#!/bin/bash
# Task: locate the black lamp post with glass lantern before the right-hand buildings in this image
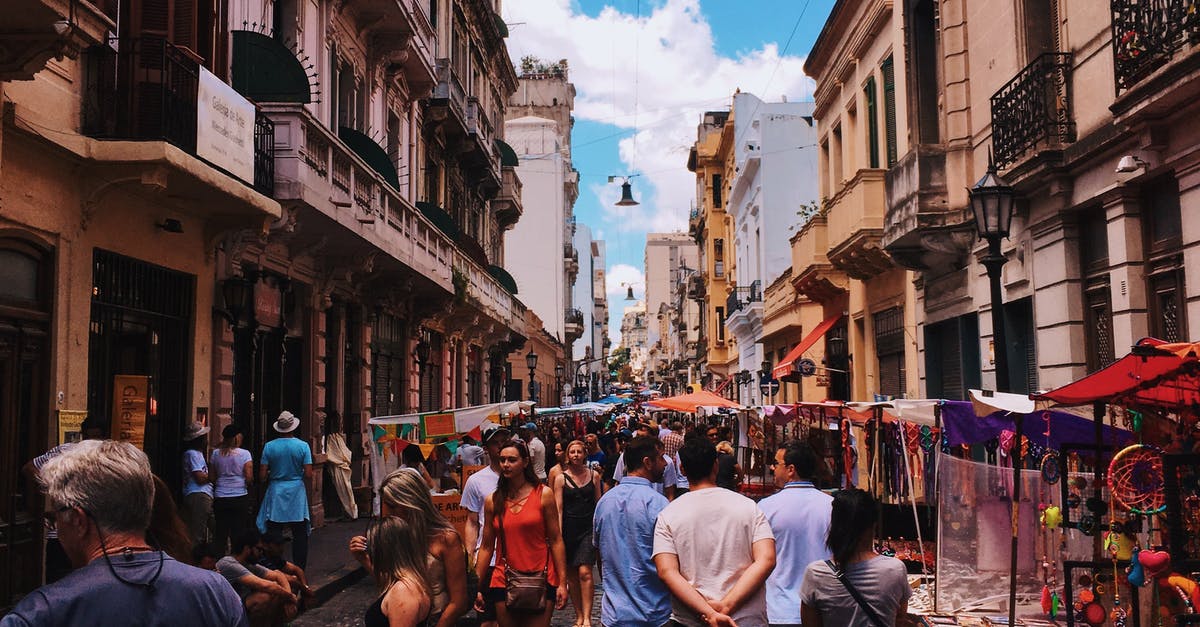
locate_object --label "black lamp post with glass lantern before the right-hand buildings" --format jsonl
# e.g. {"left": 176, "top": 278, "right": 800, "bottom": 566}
{"left": 968, "top": 155, "right": 1024, "bottom": 625}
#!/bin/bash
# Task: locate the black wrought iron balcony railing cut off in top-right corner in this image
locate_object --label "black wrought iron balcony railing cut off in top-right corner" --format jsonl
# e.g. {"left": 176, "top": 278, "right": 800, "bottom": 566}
{"left": 1110, "top": 0, "right": 1200, "bottom": 95}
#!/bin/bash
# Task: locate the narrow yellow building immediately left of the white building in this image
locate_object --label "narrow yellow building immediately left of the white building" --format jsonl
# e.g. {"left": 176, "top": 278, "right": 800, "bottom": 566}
{"left": 688, "top": 111, "right": 737, "bottom": 389}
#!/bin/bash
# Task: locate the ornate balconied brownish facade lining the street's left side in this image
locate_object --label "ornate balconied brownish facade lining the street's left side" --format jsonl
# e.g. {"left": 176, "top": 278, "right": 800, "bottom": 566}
{"left": 0, "top": 0, "right": 544, "bottom": 598}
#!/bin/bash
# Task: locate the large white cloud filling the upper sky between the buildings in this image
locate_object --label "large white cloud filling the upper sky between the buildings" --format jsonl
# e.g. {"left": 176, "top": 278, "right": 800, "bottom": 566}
{"left": 504, "top": 0, "right": 812, "bottom": 232}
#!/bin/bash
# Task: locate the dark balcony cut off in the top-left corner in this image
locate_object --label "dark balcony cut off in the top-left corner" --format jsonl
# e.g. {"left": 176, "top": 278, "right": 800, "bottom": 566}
{"left": 0, "top": 0, "right": 116, "bottom": 83}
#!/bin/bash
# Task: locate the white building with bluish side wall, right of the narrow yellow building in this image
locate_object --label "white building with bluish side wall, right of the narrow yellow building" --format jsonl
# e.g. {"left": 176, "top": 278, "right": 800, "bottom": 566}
{"left": 725, "top": 92, "right": 818, "bottom": 402}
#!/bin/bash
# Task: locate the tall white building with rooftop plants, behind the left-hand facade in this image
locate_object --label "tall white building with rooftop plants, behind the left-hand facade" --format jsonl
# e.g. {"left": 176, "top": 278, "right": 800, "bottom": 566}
{"left": 504, "top": 59, "right": 583, "bottom": 354}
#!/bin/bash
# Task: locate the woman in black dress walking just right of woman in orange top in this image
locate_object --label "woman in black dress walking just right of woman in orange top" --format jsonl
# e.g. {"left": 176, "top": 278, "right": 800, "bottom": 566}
{"left": 553, "top": 440, "right": 600, "bottom": 627}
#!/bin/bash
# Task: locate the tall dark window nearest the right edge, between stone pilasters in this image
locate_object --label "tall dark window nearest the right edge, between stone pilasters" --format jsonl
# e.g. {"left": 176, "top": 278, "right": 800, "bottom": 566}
{"left": 1142, "top": 175, "right": 1188, "bottom": 342}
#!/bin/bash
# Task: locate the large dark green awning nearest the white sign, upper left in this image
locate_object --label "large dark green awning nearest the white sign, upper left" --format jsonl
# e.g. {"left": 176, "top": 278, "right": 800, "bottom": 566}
{"left": 232, "top": 30, "right": 312, "bottom": 103}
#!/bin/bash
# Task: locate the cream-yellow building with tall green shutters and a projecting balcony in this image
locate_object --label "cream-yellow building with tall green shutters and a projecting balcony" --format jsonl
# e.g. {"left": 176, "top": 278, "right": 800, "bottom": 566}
{"left": 792, "top": 1, "right": 919, "bottom": 400}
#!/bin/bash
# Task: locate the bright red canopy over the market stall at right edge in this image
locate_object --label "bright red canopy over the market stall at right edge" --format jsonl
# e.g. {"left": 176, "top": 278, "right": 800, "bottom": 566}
{"left": 1031, "top": 338, "right": 1200, "bottom": 407}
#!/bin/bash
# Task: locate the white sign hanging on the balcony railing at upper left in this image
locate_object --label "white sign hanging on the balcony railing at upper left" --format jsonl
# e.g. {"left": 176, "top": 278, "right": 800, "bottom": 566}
{"left": 196, "top": 67, "right": 254, "bottom": 185}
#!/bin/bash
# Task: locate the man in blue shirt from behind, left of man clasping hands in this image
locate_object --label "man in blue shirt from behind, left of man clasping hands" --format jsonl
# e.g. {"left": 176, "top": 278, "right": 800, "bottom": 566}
{"left": 593, "top": 436, "right": 671, "bottom": 627}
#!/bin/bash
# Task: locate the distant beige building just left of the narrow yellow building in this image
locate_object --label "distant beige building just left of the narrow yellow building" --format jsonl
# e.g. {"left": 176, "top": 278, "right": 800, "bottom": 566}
{"left": 644, "top": 233, "right": 700, "bottom": 382}
